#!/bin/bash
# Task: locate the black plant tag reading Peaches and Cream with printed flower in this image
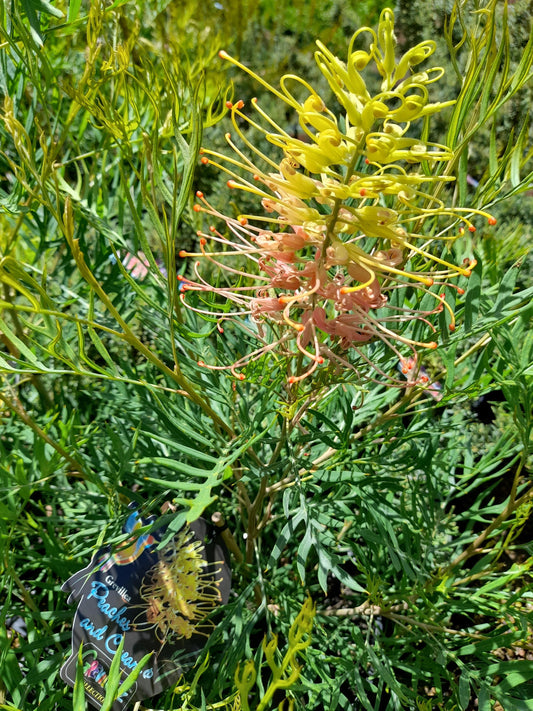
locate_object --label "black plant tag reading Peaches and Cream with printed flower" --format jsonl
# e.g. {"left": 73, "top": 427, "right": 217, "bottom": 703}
{"left": 61, "top": 512, "right": 231, "bottom": 711}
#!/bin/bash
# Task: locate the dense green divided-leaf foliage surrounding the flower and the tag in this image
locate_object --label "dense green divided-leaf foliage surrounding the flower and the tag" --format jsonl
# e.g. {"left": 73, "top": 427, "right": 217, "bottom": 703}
{"left": 0, "top": 0, "right": 533, "bottom": 711}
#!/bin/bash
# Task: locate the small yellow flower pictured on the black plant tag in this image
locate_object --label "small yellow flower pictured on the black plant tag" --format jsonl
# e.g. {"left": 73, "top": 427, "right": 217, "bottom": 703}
{"left": 135, "top": 529, "right": 221, "bottom": 644}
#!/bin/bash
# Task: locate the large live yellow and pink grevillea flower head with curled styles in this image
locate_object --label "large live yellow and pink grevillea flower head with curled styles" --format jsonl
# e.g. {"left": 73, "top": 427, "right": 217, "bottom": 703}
{"left": 180, "top": 9, "right": 495, "bottom": 386}
